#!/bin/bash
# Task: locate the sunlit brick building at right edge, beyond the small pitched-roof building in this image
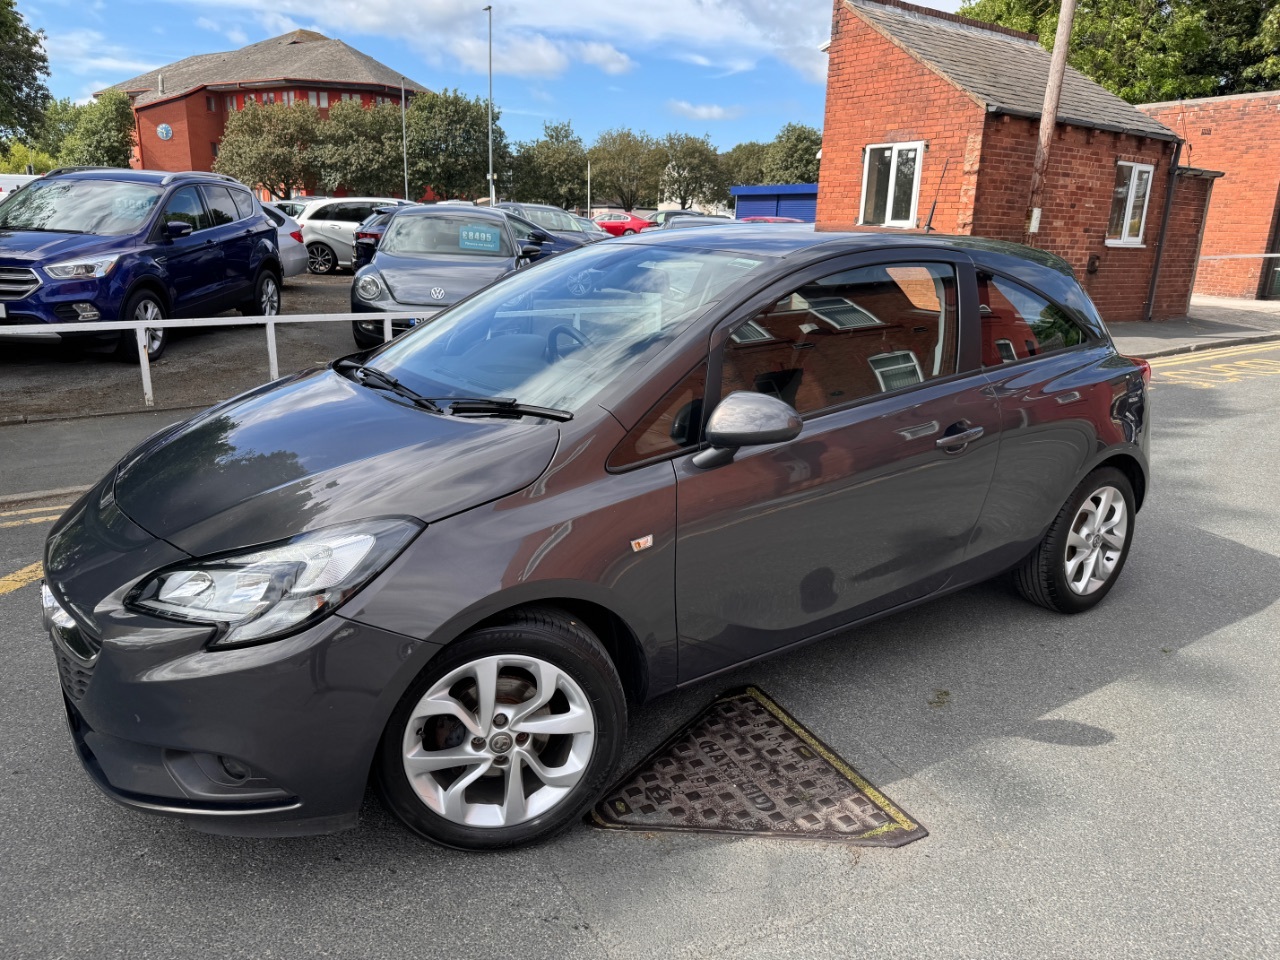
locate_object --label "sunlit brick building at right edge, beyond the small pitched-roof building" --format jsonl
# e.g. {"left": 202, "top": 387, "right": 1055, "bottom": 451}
{"left": 1138, "top": 91, "right": 1280, "bottom": 300}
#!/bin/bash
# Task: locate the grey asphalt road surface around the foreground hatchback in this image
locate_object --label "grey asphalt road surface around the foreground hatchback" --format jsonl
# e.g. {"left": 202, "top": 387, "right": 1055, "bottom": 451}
{"left": 0, "top": 344, "right": 1280, "bottom": 960}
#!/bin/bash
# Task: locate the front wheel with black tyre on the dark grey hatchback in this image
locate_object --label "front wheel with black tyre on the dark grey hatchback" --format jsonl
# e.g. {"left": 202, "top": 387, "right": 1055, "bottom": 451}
{"left": 376, "top": 608, "right": 626, "bottom": 850}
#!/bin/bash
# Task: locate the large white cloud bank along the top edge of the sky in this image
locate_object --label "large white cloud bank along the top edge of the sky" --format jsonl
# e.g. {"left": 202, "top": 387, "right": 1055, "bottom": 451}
{"left": 165, "top": 0, "right": 834, "bottom": 82}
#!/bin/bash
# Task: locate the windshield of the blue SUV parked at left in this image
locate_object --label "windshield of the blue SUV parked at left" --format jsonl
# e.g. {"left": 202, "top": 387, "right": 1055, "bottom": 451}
{"left": 0, "top": 179, "right": 164, "bottom": 237}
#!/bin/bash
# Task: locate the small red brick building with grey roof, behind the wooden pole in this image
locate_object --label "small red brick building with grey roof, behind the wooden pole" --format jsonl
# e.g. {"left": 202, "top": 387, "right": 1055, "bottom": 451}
{"left": 818, "top": 0, "right": 1220, "bottom": 320}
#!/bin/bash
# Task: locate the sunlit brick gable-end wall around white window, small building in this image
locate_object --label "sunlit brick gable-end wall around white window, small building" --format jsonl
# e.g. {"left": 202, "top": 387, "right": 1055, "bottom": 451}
{"left": 818, "top": 0, "right": 983, "bottom": 233}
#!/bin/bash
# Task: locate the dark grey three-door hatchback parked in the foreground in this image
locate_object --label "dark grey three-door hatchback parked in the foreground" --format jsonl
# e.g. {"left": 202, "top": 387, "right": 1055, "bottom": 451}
{"left": 44, "top": 224, "right": 1149, "bottom": 849}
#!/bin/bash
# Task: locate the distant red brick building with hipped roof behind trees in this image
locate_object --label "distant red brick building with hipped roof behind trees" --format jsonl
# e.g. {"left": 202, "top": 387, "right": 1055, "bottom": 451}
{"left": 106, "top": 29, "right": 426, "bottom": 185}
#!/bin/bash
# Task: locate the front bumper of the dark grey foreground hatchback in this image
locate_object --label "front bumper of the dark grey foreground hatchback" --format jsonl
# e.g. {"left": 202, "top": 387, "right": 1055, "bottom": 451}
{"left": 45, "top": 586, "right": 436, "bottom": 836}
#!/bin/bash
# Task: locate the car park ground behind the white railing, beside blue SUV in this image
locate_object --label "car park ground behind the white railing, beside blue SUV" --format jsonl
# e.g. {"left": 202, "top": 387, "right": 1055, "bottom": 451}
{"left": 0, "top": 271, "right": 356, "bottom": 422}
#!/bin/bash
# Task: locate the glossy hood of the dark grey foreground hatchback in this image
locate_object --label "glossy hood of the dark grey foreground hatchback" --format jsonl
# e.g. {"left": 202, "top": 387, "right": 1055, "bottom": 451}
{"left": 115, "top": 370, "right": 559, "bottom": 556}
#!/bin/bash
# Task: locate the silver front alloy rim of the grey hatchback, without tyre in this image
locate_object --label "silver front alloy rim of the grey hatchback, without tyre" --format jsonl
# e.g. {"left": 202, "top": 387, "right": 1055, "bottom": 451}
{"left": 402, "top": 654, "right": 595, "bottom": 827}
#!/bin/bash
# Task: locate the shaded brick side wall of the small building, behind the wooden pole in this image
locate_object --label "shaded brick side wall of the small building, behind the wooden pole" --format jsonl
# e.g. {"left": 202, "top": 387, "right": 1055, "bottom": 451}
{"left": 973, "top": 116, "right": 1172, "bottom": 321}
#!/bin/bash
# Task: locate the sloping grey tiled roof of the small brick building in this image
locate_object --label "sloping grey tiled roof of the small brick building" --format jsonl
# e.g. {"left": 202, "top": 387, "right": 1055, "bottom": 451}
{"left": 845, "top": 0, "right": 1178, "bottom": 140}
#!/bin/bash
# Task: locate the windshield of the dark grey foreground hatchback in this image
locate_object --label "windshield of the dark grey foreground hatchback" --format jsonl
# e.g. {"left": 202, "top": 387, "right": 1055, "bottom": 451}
{"left": 369, "top": 241, "right": 765, "bottom": 413}
